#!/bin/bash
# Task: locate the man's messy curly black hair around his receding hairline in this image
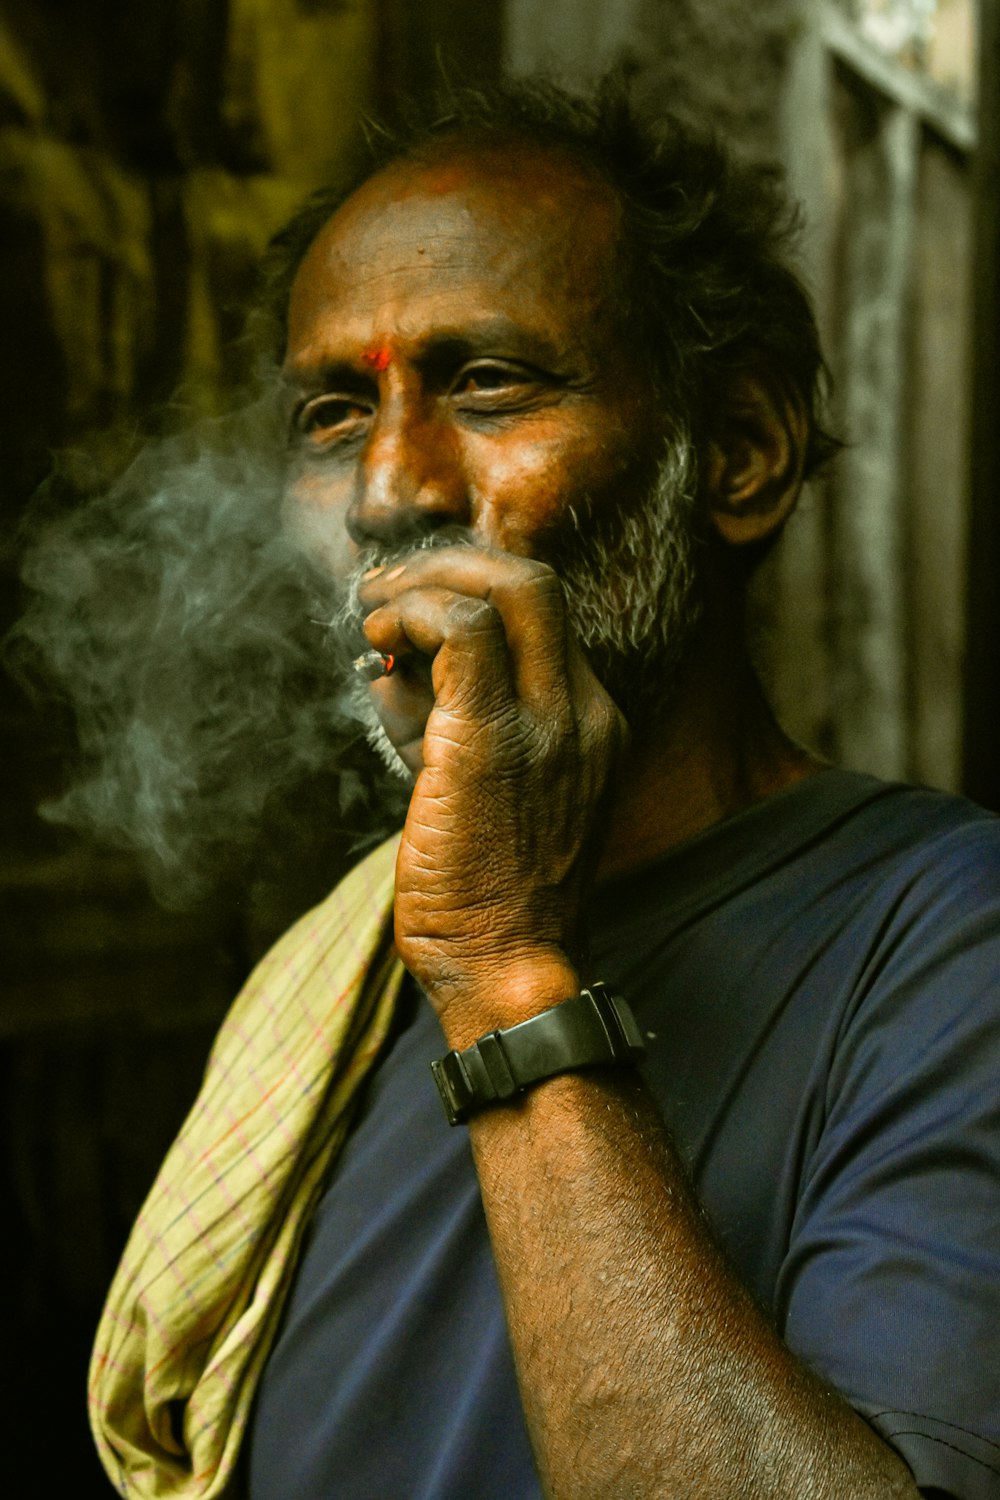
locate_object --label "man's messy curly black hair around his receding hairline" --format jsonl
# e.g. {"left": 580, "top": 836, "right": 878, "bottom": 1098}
{"left": 258, "top": 78, "right": 840, "bottom": 477}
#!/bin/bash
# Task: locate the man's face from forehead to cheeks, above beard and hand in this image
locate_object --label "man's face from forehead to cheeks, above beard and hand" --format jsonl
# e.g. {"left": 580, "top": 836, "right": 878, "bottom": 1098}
{"left": 285, "top": 149, "right": 660, "bottom": 573}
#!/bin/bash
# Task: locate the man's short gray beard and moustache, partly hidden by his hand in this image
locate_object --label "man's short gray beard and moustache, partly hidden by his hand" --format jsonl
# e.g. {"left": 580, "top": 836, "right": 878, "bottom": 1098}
{"left": 331, "top": 440, "right": 702, "bottom": 782}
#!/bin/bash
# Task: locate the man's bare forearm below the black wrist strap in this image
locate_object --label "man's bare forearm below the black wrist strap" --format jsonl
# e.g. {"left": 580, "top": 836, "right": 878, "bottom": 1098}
{"left": 471, "top": 1071, "right": 918, "bottom": 1500}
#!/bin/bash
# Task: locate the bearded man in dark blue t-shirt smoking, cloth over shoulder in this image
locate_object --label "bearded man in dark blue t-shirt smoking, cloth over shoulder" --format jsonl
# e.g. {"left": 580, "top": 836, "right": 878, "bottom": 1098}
{"left": 91, "top": 79, "right": 1000, "bottom": 1500}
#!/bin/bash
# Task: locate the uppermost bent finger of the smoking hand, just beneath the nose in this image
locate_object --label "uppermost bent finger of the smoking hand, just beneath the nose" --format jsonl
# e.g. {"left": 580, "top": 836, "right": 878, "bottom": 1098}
{"left": 358, "top": 546, "right": 570, "bottom": 710}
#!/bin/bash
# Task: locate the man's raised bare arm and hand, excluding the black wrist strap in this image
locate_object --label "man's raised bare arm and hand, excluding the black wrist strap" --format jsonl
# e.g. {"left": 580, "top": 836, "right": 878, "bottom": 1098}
{"left": 359, "top": 549, "right": 918, "bottom": 1500}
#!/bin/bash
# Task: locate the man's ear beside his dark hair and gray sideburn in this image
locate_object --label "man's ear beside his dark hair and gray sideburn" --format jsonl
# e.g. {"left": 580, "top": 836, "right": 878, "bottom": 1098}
{"left": 705, "top": 371, "right": 808, "bottom": 546}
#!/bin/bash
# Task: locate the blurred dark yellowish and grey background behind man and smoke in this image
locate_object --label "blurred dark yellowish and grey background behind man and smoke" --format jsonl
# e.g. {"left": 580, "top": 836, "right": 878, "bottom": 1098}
{"left": 0, "top": 0, "right": 997, "bottom": 1500}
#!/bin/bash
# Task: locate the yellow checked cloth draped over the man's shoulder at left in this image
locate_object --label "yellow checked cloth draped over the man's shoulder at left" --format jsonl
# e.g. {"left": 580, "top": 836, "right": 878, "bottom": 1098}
{"left": 90, "top": 839, "right": 403, "bottom": 1500}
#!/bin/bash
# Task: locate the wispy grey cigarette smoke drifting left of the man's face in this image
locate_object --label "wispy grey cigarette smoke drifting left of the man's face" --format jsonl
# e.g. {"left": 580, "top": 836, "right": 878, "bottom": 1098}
{"left": 10, "top": 395, "right": 406, "bottom": 905}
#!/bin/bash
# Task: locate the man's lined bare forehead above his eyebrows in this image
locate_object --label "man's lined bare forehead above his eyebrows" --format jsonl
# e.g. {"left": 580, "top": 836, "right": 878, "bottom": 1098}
{"left": 289, "top": 147, "right": 618, "bottom": 363}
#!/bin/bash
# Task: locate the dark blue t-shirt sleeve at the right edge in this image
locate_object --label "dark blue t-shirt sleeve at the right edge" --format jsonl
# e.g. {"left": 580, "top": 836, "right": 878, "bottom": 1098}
{"left": 777, "top": 822, "right": 1000, "bottom": 1500}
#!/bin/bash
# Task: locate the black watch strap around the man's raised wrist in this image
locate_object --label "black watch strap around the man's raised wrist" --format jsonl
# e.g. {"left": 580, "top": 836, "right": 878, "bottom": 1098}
{"left": 430, "top": 983, "right": 645, "bottom": 1125}
